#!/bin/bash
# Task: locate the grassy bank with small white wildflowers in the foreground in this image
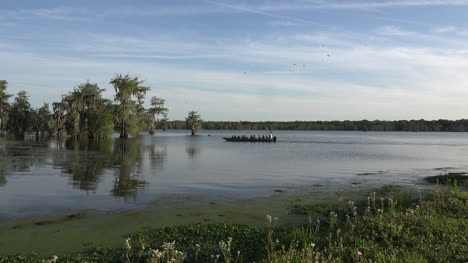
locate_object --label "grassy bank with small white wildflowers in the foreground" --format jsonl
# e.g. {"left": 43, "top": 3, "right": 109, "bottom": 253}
{"left": 0, "top": 179, "right": 468, "bottom": 263}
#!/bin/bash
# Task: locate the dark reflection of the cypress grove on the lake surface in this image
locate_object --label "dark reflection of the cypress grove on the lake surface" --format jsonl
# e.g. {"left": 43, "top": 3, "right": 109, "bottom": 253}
{"left": 0, "top": 138, "right": 167, "bottom": 197}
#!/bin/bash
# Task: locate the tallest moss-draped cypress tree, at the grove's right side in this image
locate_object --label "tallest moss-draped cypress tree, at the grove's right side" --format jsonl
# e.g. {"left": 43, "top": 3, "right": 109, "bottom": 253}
{"left": 110, "top": 75, "right": 149, "bottom": 138}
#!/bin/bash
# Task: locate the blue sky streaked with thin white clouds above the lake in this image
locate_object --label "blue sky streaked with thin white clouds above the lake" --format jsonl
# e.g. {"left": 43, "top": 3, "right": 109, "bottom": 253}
{"left": 0, "top": 0, "right": 468, "bottom": 121}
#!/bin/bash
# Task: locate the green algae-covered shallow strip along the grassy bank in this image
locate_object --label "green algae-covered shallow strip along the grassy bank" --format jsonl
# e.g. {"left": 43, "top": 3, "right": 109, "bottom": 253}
{"left": 0, "top": 185, "right": 434, "bottom": 256}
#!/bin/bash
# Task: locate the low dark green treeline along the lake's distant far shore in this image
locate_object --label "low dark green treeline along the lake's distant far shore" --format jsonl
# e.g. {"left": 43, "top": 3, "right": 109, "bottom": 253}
{"left": 166, "top": 119, "right": 468, "bottom": 132}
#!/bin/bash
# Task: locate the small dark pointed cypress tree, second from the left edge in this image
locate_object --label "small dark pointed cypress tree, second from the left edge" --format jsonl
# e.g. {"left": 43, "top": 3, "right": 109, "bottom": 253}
{"left": 7, "top": 90, "right": 32, "bottom": 138}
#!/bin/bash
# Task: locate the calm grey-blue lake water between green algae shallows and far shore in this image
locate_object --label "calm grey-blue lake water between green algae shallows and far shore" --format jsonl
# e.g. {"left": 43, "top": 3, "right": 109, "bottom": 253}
{"left": 0, "top": 131, "right": 468, "bottom": 218}
